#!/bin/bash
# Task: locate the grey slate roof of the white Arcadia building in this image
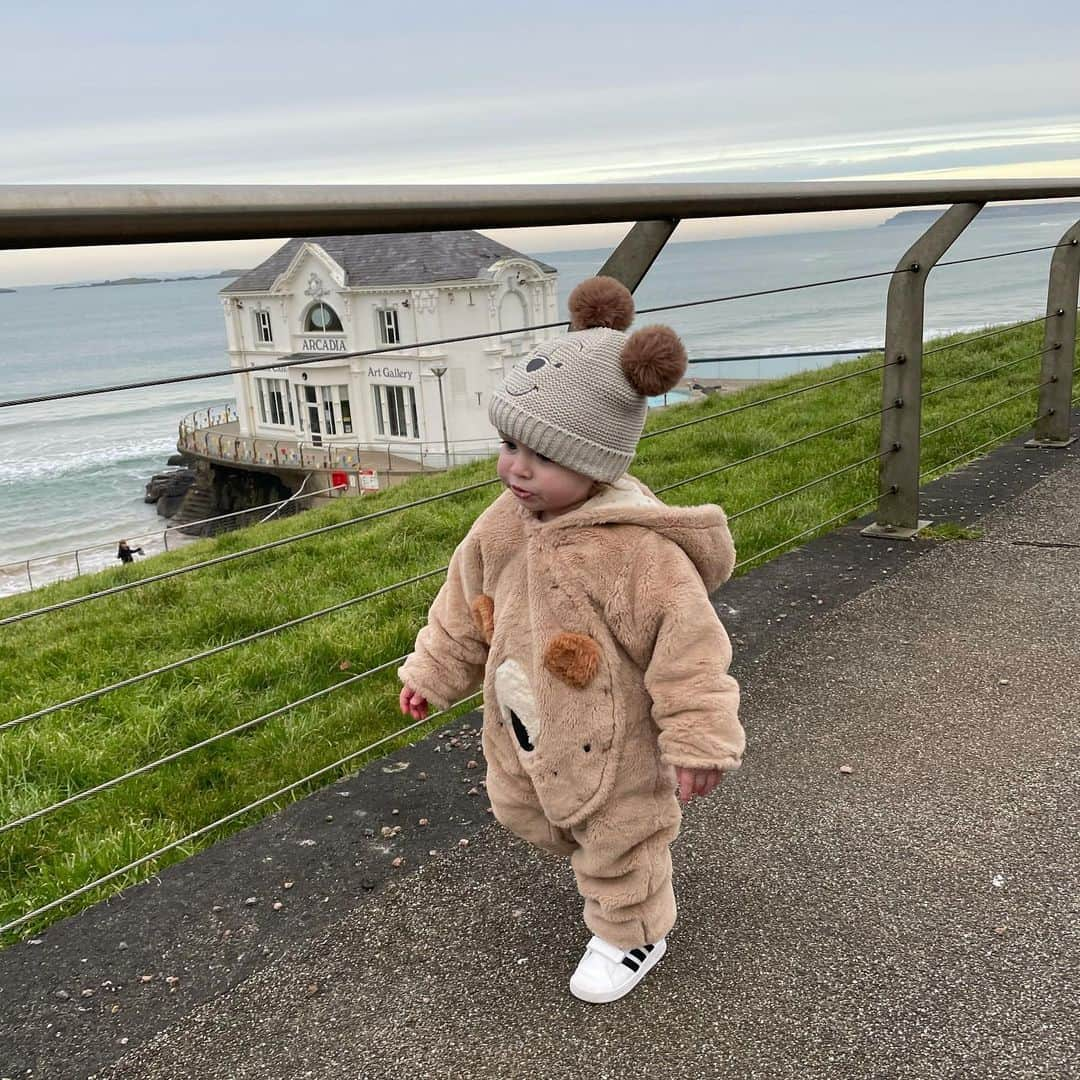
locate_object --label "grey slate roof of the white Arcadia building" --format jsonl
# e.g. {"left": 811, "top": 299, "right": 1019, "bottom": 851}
{"left": 221, "top": 230, "right": 556, "bottom": 293}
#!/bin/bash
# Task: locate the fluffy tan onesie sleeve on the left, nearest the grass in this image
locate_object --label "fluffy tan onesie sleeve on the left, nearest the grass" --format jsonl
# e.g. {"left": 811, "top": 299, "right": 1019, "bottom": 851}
{"left": 397, "top": 534, "right": 488, "bottom": 708}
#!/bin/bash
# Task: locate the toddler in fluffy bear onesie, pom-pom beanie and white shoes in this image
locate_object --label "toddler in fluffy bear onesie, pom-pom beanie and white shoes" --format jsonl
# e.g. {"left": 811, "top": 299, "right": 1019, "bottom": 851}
{"left": 399, "top": 278, "right": 744, "bottom": 1002}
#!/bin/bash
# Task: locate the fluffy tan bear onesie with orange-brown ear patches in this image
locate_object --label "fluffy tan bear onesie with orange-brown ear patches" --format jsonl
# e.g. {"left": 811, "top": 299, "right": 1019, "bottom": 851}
{"left": 399, "top": 474, "right": 744, "bottom": 949}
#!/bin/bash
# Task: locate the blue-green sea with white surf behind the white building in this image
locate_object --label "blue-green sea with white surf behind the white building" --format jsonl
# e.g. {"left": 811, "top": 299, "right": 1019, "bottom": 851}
{"left": 0, "top": 204, "right": 1077, "bottom": 595}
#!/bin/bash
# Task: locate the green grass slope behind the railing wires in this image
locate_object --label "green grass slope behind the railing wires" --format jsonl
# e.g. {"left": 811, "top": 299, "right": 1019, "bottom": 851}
{"left": 0, "top": 315, "right": 1075, "bottom": 940}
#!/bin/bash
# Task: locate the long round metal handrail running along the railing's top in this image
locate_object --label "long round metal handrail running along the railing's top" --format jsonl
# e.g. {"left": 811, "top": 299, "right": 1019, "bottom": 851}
{"left": 0, "top": 177, "right": 1080, "bottom": 249}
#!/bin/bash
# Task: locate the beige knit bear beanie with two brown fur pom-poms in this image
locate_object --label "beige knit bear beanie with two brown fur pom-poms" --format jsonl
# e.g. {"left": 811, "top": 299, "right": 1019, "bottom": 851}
{"left": 487, "top": 278, "right": 686, "bottom": 483}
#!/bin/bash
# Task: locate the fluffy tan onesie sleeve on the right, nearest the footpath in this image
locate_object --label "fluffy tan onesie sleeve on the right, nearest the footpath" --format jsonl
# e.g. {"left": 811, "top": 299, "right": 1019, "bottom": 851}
{"left": 627, "top": 538, "right": 746, "bottom": 771}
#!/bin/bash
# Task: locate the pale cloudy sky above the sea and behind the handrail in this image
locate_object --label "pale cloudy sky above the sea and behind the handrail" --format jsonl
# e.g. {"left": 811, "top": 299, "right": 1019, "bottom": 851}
{"left": 0, "top": 0, "right": 1080, "bottom": 285}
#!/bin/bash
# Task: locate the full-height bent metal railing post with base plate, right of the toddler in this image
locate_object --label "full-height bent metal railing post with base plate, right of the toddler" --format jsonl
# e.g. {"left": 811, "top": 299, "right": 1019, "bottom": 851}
{"left": 863, "top": 203, "right": 984, "bottom": 540}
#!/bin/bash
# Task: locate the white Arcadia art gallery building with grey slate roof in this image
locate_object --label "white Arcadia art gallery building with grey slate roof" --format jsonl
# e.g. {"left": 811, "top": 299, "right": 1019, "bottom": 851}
{"left": 221, "top": 232, "right": 558, "bottom": 465}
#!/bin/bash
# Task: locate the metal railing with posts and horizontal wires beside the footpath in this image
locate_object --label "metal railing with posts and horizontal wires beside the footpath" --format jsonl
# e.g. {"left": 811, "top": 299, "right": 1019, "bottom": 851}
{"left": 0, "top": 180, "right": 1080, "bottom": 932}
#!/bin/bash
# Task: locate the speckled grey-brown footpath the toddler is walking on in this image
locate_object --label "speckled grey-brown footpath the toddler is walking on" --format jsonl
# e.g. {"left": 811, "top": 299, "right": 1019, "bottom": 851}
{"left": 0, "top": 432, "right": 1080, "bottom": 1080}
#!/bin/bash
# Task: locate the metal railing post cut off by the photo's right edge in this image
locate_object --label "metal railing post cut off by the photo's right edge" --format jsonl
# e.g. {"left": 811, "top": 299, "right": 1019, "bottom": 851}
{"left": 1024, "top": 221, "right": 1080, "bottom": 449}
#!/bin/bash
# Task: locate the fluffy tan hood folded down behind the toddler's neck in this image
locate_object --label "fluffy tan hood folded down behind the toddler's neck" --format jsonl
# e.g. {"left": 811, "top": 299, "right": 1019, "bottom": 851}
{"left": 501, "top": 473, "right": 735, "bottom": 592}
